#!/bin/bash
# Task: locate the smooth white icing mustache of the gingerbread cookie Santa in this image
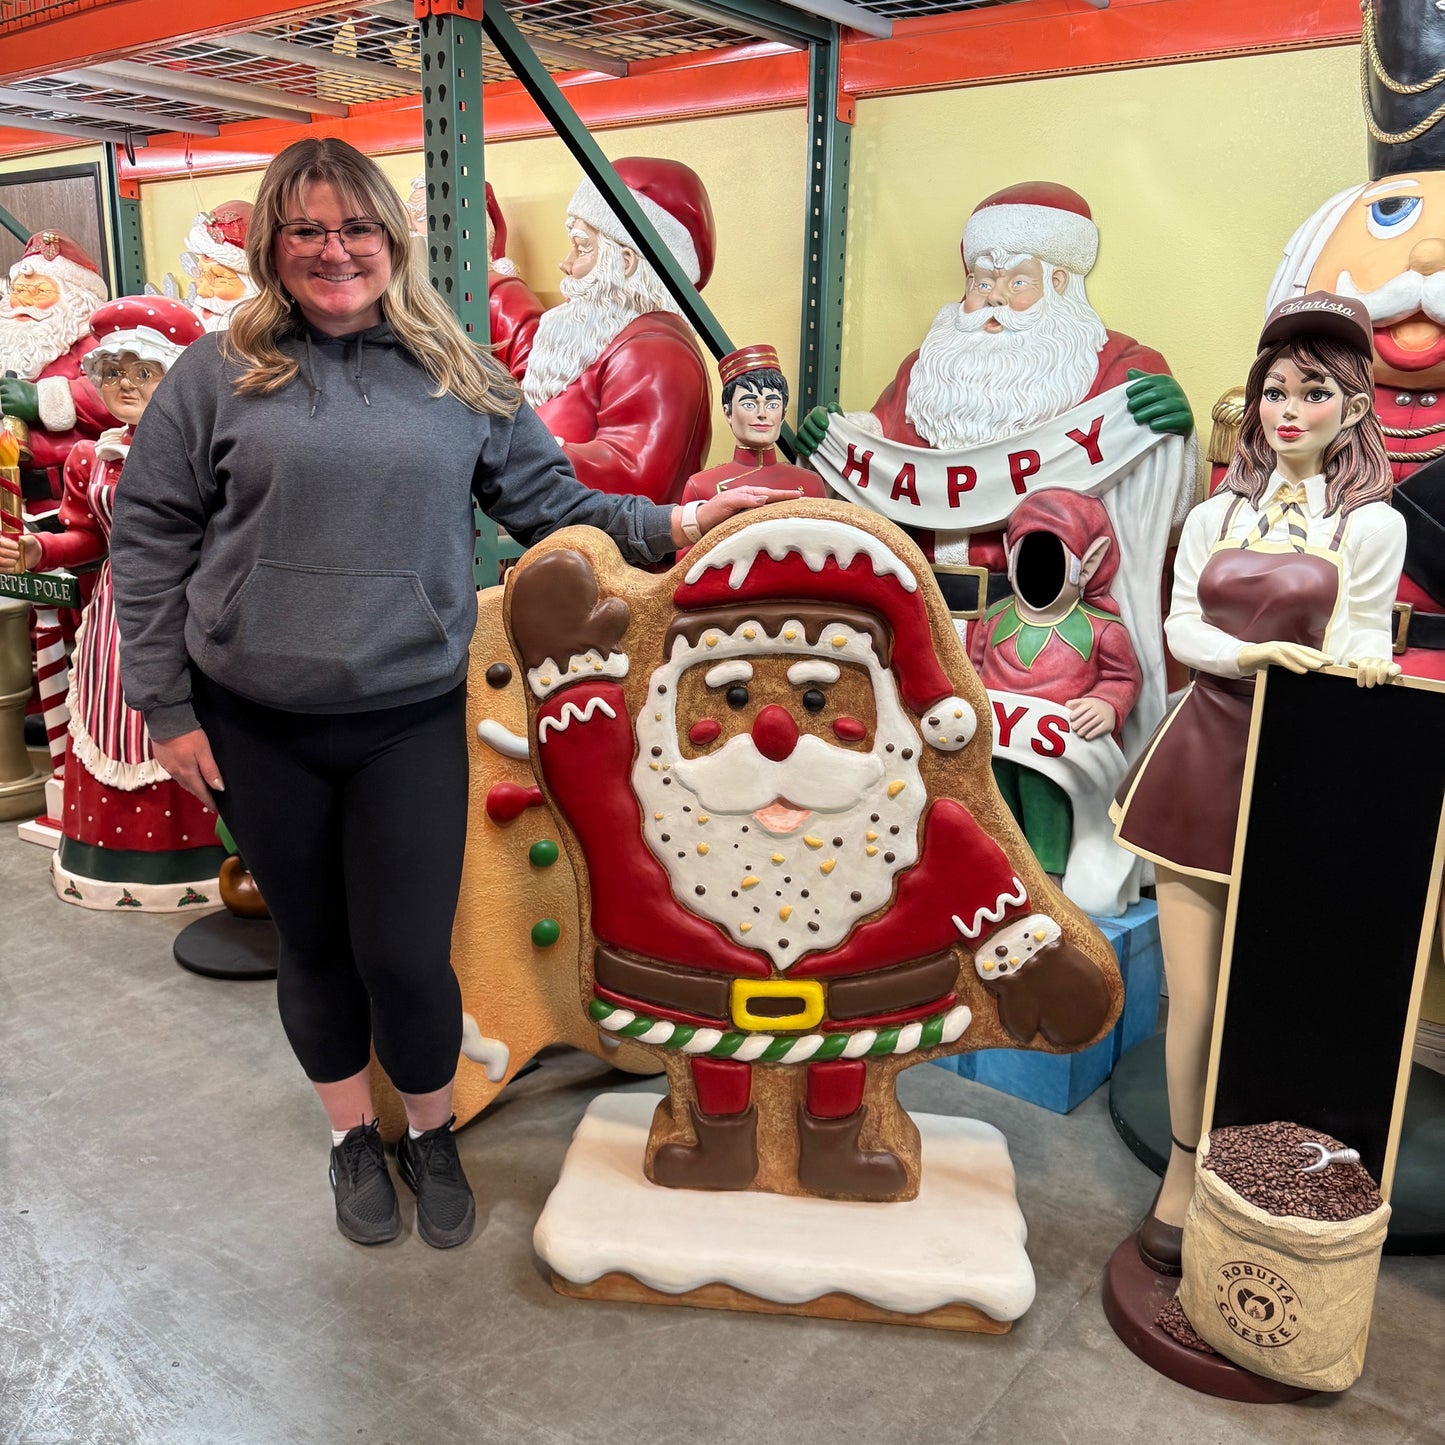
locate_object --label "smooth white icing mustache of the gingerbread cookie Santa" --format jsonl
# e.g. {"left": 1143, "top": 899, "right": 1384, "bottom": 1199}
{"left": 673, "top": 734, "right": 883, "bottom": 814}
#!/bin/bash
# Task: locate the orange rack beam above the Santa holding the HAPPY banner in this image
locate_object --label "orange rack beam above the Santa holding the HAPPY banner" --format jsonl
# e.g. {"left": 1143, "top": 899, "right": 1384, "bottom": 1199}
{"left": 842, "top": 0, "right": 1360, "bottom": 95}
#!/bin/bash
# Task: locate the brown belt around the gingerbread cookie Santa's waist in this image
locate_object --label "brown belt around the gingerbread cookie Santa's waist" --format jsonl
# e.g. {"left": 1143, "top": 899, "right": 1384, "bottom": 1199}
{"left": 594, "top": 945, "right": 958, "bottom": 1027}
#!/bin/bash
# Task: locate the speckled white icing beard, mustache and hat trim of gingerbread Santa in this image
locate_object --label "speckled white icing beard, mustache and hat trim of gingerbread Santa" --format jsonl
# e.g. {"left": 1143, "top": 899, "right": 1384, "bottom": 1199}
{"left": 631, "top": 621, "right": 928, "bottom": 971}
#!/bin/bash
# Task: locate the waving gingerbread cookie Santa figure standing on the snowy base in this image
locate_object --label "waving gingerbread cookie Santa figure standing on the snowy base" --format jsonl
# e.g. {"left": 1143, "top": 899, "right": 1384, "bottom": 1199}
{"left": 507, "top": 500, "right": 1121, "bottom": 1201}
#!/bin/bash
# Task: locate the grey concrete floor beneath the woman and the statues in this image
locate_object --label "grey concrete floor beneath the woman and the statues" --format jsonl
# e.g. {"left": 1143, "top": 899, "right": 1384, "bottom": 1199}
{"left": 0, "top": 825, "right": 1445, "bottom": 1445}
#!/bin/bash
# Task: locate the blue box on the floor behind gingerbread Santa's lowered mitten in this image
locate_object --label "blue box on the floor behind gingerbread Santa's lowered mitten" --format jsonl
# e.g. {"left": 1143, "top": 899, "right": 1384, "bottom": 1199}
{"left": 936, "top": 899, "right": 1163, "bottom": 1114}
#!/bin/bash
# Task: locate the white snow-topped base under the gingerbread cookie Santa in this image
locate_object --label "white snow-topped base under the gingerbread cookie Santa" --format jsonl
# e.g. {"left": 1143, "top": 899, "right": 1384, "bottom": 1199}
{"left": 533, "top": 1094, "right": 1035, "bottom": 1334}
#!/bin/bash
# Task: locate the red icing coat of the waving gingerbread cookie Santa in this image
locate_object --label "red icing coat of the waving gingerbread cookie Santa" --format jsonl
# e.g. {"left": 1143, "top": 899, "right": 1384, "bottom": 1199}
{"left": 538, "top": 681, "right": 1030, "bottom": 1027}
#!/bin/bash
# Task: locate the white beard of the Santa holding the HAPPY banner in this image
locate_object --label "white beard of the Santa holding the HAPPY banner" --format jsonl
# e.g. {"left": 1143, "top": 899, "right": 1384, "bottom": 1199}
{"left": 905, "top": 276, "right": 1108, "bottom": 451}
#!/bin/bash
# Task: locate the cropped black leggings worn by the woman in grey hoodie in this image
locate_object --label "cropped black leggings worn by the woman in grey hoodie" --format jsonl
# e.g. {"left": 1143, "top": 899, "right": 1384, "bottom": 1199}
{"left": 195, "top": 673, "right": 467, "bottom": 1094}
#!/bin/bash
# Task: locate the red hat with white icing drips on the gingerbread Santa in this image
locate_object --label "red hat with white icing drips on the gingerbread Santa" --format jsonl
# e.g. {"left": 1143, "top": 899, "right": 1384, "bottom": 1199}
{"left": 672, "top": 517, "right": 977, "bottom": 753}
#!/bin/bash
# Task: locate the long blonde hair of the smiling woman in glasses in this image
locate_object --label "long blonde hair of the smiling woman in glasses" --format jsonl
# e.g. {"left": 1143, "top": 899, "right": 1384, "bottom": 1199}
{"left": 221, "top": 137, "right": 522, "bottom": 416}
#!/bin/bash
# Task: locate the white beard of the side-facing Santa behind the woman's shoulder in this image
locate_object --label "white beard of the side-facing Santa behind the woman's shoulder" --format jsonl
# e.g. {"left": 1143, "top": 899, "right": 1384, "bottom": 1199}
{"left": 522, "top": 236, "right": 678, "bottom": 406}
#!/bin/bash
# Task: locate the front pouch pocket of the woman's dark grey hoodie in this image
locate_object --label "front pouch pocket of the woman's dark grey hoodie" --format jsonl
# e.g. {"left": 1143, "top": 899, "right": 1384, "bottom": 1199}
{"left": 198, "top": 561, "right": 457, "bottom": 708}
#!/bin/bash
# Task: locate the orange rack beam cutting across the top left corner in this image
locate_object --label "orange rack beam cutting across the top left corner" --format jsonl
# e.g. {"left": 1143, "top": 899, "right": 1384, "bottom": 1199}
{"left": 0, "top": 0, "right": 337, "bottom": 84}
